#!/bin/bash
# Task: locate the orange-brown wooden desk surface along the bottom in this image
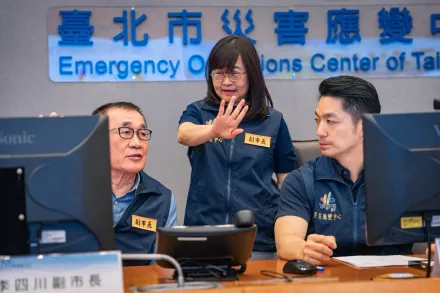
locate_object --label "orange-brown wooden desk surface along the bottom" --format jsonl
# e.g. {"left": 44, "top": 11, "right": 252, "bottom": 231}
{"left": 123, "top": 260, "right": 440, "bottom": 293}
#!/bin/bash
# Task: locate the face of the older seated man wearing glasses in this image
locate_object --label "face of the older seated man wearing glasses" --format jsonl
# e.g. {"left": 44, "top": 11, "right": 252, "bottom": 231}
{"left": 107, "top": 108, "right": 149, "bottom": 173}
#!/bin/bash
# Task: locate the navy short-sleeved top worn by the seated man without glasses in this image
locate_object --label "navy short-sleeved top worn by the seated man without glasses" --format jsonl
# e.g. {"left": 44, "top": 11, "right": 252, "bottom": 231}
{"left": 277, "top": 157, "right": 411, "bottom": 256}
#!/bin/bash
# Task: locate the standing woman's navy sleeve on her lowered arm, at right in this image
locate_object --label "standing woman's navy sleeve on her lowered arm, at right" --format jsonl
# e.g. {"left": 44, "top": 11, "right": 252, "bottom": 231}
{"left": 274, "top": 118, "right": 296, "bottom": 174}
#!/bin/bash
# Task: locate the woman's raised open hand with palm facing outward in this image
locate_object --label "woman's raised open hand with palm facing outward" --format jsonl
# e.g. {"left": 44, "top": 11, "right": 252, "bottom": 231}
{"left": 211, "top": 96, "right": 249, "bottom": 139}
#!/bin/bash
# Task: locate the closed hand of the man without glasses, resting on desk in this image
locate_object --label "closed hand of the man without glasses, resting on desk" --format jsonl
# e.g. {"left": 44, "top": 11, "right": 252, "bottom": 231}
{"left": 303, "top": 234, "right": 337, "bottom": 266}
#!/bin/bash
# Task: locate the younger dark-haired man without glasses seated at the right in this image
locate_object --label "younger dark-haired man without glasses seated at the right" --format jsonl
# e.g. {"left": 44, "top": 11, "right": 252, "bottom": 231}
{"left": 275, "top": 76, "right": 411, "bottom": 265}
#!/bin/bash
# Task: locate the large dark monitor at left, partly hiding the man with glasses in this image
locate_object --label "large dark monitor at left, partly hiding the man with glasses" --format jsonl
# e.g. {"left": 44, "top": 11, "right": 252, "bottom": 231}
{"left": 0, "top": 116, "right": 114, "bottom": 255}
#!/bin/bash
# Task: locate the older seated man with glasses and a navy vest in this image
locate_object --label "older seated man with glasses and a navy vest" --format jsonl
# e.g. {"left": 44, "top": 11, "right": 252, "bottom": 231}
{"left": 93, "top": 102, "right": 177, "bottom": 265}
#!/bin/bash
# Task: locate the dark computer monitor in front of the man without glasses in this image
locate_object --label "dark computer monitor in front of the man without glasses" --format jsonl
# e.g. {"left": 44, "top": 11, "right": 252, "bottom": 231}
{"left": 363, "top": 112, "right": 440, "bottom": 245}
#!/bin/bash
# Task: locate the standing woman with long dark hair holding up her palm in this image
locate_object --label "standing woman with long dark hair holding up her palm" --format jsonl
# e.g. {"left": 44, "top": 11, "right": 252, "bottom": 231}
{"left": 177, "top": 35, "right": 296, "bottom": 259}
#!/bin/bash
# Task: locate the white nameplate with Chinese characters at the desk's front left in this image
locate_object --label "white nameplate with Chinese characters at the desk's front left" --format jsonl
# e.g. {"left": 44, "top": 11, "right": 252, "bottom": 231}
{"left": 0, "top": 251, "right": 124, "bottom": 293}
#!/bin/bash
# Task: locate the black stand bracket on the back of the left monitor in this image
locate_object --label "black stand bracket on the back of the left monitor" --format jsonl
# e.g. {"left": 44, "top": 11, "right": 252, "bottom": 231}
{"left": 0, "top": 167, "right": 30, "bottom": 255}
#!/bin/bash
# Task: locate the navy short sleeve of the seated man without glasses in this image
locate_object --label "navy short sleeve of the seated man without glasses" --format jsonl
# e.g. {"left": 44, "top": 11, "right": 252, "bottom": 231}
{"left": 277, "top": 170, "right": 312, "bottom": 222}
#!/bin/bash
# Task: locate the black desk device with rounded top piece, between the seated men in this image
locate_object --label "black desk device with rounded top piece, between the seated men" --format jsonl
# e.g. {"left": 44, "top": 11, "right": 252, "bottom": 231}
{"left": 156, "top": 211, "right": 257, "bottom": 281}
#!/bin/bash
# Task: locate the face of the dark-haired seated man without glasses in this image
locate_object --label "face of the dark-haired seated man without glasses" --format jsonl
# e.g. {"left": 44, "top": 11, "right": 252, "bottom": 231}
{"left": 315, "top": 96, "right": 363, "bottom": 159}
